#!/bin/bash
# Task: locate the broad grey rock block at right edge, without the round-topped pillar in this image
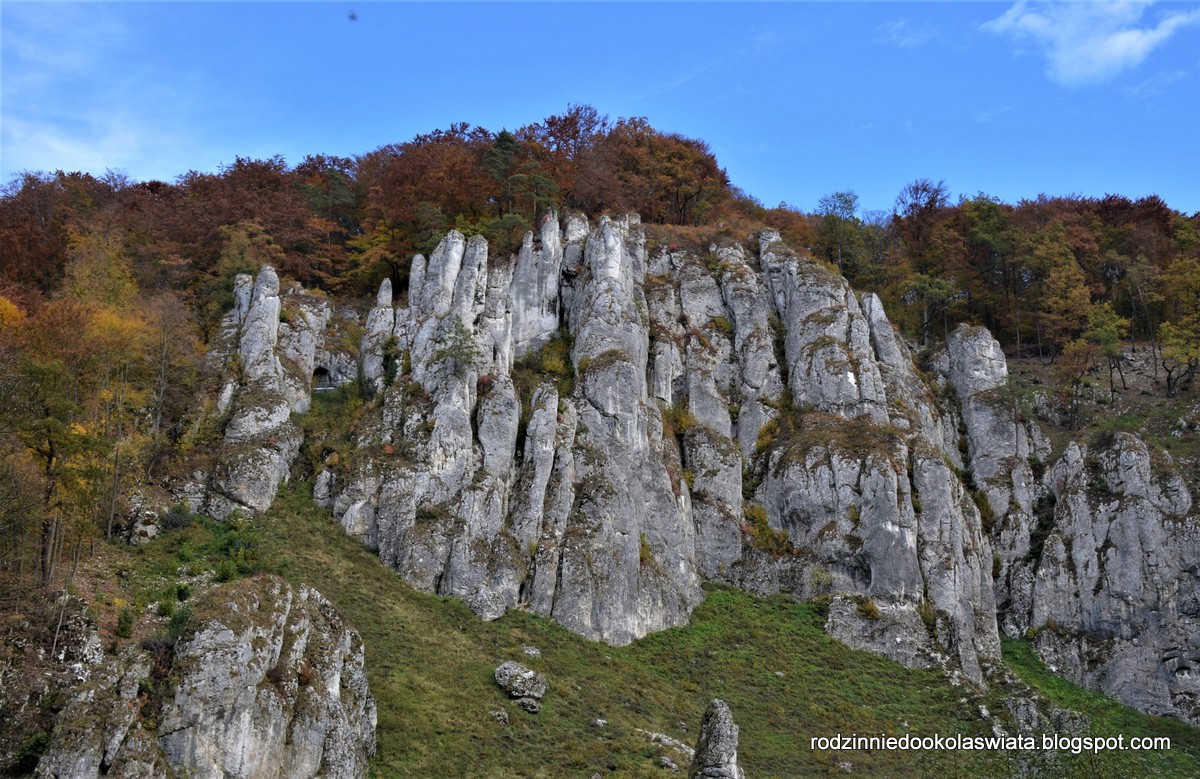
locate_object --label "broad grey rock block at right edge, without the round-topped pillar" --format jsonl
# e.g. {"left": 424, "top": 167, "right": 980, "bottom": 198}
{"left": 1028, "top": 433, "right": 1200, "bottom": 725}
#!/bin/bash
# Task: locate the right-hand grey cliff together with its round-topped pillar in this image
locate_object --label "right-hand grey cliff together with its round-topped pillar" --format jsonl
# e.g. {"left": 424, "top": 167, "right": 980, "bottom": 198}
{"left": 936, "top": 326, "right": 1200, "bottom": 724}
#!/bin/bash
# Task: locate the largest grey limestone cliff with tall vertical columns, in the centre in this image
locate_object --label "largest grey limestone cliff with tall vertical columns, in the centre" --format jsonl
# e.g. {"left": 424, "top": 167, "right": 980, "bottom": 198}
{"left": 319, "top": 217, "right": 998, "bottom": 679}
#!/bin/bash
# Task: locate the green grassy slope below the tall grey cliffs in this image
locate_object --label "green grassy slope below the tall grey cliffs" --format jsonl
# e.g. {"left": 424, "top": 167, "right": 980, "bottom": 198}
{"left": 236, "top": 487, "right": 1200, "bottom": 778}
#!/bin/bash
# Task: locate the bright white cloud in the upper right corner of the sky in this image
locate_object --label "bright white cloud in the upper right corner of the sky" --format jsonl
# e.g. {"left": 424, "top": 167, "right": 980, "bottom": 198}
{"left": 983, "top": 0, "right": 1200, "bottom": 86}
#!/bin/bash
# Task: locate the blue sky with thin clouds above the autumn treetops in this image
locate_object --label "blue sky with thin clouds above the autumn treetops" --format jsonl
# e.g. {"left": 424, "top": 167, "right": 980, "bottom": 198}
{"left": 0, "top": 0, "right": 1200, "bottom": 212}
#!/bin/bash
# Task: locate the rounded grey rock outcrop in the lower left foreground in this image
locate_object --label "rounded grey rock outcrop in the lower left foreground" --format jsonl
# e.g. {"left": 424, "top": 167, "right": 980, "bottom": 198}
{"left": 36, "top": 576, "right": 376, "bottom": 779}
